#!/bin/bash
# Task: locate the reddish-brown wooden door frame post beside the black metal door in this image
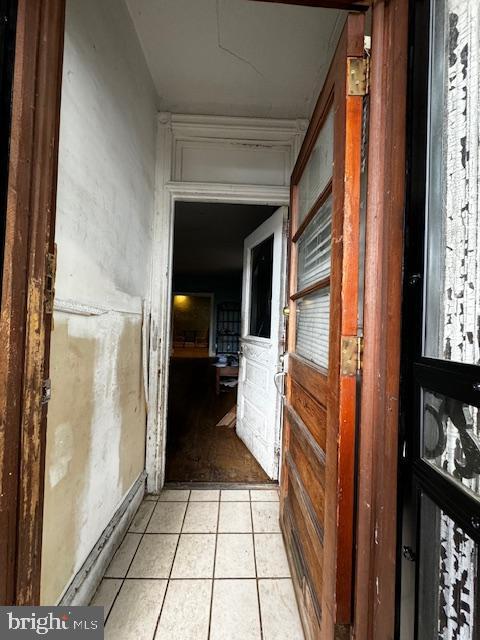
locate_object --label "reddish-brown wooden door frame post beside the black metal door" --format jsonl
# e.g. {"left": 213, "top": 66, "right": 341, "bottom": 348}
{"left": 354, "top": 0, "right": 409, "bottom": 640}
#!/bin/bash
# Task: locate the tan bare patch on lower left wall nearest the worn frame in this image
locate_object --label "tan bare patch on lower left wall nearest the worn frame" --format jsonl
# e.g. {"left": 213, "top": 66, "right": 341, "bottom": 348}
{"left": 41, "top": 317, "right": 97, "bottom": 605}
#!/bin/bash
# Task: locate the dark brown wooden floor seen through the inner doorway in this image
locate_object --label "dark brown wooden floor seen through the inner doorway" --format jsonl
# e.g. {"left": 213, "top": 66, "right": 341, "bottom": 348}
{"left": 166, "top": 358, "right": 270, "bottom": 483}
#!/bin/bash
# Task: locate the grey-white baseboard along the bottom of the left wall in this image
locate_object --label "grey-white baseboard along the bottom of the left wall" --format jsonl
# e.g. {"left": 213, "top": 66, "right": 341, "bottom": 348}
{"left": 58, "top": 472, "right": 147, "bottom": 607}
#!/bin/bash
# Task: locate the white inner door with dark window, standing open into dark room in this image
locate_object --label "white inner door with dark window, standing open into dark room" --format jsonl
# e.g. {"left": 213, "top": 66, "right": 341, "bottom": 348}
{"left": 237, "top": 207, "right": 287, "bottom": 480}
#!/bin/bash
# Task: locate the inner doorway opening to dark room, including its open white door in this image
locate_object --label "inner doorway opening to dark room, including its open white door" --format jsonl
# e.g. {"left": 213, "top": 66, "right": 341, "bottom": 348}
{"left": 166, "top": 201, "right": 286, "bottom": 484}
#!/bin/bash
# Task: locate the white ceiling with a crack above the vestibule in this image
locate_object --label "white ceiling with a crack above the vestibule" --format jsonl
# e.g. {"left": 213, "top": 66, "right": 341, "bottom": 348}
{"left": 126, "top": 0, "right": 345, "bottom": 118}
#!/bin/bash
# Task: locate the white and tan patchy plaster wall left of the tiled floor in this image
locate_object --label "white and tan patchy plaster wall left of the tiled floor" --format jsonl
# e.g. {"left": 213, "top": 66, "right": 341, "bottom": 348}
{"left": 41, "top": 0, "right": 156, "bottom": 604}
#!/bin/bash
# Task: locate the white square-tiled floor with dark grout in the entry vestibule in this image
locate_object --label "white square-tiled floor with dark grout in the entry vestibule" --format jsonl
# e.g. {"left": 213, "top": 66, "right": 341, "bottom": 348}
{"left": 92, "top": 489, "right": 304, "bottom": 640}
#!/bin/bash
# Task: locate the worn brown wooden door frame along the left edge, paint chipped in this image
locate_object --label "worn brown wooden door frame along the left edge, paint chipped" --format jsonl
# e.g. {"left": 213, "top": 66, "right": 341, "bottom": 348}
{"left": 0, "top": 0, "right": 65, "bottom": 605}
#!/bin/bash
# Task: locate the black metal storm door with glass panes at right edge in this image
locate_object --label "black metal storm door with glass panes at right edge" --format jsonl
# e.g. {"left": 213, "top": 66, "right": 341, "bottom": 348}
{"left": 397, "top": 0, "right": 480, "bottom": 640}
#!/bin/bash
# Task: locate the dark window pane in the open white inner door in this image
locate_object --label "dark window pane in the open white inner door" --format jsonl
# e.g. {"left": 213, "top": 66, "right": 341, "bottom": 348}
{"left": 249, "top": 236, "right": 273, "bottom": 338}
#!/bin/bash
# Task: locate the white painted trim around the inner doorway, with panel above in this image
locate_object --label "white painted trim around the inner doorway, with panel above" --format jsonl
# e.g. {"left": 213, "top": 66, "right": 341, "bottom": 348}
{"left": 146, "top": 113, "right": 308, "bottom": 493}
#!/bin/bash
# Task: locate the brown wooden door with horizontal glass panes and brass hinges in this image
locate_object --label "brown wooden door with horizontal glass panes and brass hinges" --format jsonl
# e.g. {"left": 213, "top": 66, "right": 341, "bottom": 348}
{"left": 281, "top": 14, "right": 364, "bottom": 640}
